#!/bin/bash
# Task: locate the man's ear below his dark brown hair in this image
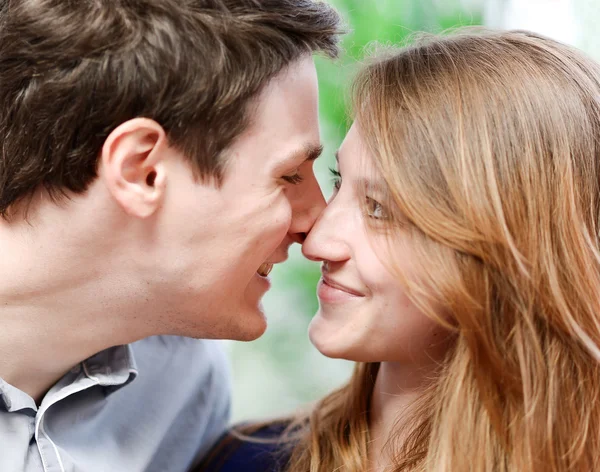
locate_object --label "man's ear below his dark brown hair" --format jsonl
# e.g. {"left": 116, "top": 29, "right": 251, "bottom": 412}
{"left": 99, "top": 118, "right": 168, "bottom": 218}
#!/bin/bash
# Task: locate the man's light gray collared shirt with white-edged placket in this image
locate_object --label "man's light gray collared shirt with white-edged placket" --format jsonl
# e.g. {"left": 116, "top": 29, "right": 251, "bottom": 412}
{"left": 0, "top": 336, "right": 230, "bottom": 472}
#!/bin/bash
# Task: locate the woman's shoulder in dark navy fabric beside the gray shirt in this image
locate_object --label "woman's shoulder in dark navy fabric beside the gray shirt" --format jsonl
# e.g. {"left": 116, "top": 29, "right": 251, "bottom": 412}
{"left": 195, "top": 422, "right": 291, "bottom": 472}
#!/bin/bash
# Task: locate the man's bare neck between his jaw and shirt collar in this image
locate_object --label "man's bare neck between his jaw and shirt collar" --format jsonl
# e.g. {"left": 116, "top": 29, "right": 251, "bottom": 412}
{"left": 0, "top": 214, "right": 144, "bottom": 402}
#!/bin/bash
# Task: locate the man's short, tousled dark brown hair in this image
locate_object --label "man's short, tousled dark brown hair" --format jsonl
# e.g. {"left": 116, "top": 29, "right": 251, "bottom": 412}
{"left": 0, "top": 0, "right": 341, "bottom": 217}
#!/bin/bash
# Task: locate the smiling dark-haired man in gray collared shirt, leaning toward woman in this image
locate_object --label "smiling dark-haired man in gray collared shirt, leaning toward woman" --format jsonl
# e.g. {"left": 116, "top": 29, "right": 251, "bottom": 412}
{"left": 0, "top": 0, "right": 339, "bottom": 472}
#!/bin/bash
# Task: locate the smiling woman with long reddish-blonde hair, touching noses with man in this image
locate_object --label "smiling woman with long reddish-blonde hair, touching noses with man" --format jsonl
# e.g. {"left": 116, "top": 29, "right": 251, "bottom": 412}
{"left": 199, "top": 31, "right": 600, "bottom": 472}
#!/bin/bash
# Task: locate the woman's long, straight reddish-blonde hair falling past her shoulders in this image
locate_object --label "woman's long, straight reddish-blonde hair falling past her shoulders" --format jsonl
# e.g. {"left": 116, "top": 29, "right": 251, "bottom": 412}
{"left": 287, "top": 30, "right": 600, "bottom": 472}
